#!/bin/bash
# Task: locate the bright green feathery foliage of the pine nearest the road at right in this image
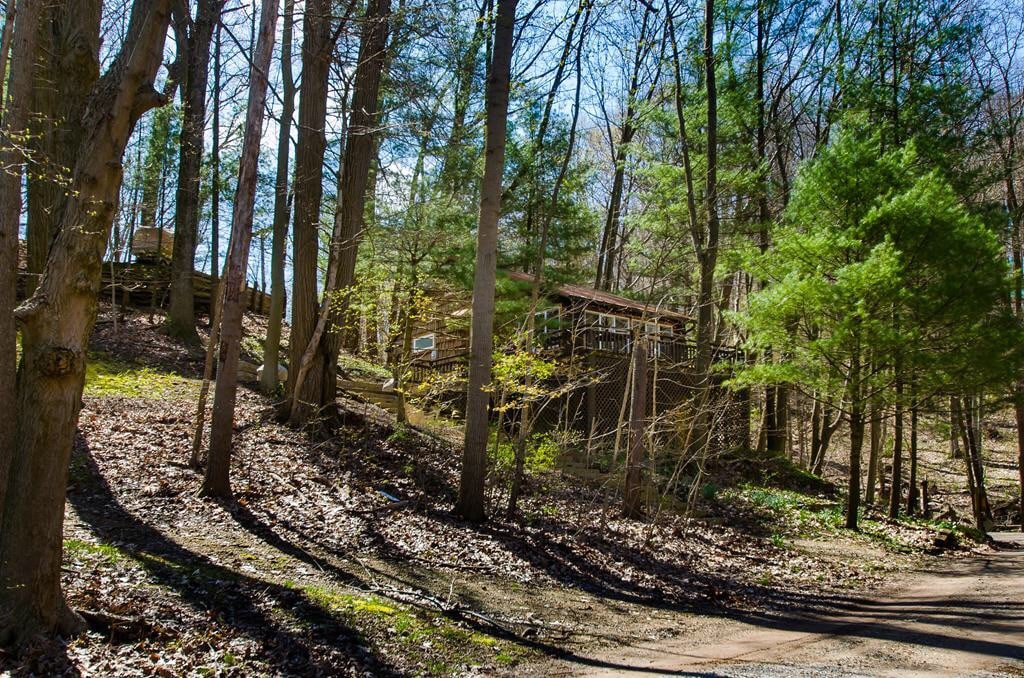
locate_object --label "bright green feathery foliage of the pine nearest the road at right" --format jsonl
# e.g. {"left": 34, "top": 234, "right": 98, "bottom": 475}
{"left": 733, "top": 125, "right": 1020, "bottom": 405}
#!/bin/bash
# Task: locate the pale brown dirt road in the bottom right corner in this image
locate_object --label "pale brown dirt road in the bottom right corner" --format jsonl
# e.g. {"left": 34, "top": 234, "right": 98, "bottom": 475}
{"left": 549, "top": 535, "right": 1024, "bottom": 677}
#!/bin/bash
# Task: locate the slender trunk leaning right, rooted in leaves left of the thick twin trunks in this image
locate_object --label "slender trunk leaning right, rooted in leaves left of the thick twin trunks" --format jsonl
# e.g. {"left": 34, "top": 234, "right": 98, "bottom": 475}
{"left": 200, "top": 0, "right": 278, "bottom": 498}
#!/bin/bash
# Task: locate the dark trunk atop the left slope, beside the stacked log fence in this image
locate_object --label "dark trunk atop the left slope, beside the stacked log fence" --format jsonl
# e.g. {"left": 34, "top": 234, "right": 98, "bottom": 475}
{"left": 167, "top": 0, "right": 225, "bottom": 344}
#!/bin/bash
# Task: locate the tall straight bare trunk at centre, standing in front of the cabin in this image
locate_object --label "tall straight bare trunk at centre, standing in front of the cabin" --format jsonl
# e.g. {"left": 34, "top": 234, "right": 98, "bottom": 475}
{"left": 456, "top": 0, "right": 517, "bottom": 522}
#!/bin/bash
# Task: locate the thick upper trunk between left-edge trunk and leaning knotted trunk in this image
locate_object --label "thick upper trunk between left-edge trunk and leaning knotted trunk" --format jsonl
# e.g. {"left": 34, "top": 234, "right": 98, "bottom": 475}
{"left": 27, "top": 0, "right": 100, "bottom": 294}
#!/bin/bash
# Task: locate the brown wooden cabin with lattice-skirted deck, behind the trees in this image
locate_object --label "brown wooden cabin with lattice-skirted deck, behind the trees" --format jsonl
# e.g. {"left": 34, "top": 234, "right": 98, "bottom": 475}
{"left": 412, "top": 272, "right": 750, "bottom": 449}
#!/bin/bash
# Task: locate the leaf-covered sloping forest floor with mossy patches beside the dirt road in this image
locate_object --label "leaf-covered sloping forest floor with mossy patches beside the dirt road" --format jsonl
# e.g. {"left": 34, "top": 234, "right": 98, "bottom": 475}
{"left": 0, "top": 309, "right": 1019, "bottom": 676}
